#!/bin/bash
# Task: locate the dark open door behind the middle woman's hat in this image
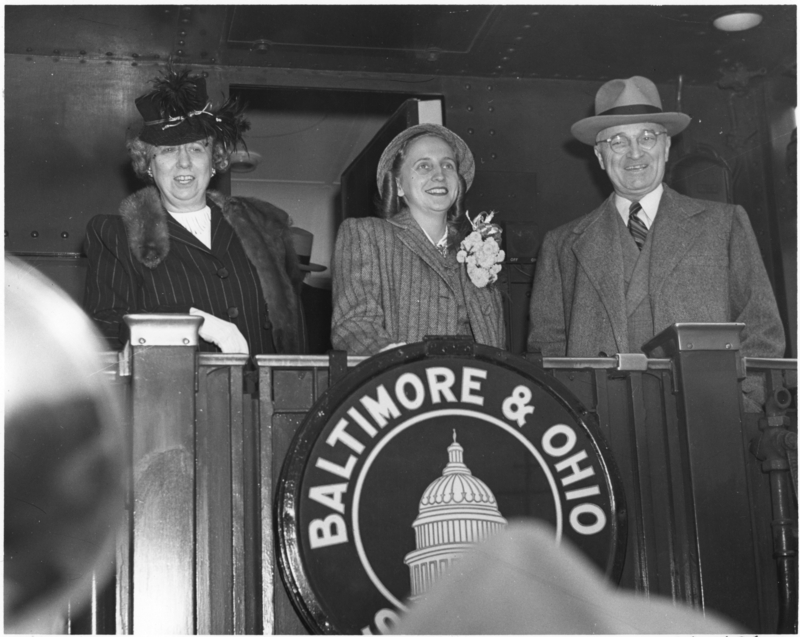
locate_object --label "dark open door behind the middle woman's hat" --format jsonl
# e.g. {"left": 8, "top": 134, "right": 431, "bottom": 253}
{"left": 335, "top": 99, "right": 442, "bottom": 228}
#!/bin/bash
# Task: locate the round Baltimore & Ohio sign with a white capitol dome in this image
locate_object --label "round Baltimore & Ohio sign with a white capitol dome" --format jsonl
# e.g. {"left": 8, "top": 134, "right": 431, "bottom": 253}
{"left": 276, "top": 339, "right": 625, "bottom": 634}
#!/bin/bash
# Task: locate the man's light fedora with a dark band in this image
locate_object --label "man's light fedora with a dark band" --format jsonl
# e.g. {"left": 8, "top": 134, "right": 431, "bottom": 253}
{"left": 572, "top": 75, "right": 692, "bottom": 146}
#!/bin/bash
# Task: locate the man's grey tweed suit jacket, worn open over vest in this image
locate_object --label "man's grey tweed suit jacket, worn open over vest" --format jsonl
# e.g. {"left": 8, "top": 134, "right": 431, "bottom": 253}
{"left": 528, "top": 185, "right": 785, "bottom": 357}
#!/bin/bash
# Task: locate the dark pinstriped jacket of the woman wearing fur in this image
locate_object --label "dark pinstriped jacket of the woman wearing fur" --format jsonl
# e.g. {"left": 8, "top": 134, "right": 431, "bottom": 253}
{"left": 84, "top": 203, "right": 275, "bottom": 355}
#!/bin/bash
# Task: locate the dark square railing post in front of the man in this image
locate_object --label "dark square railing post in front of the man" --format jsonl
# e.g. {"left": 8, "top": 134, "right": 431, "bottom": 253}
{"left": 642, "top": 323, "right": 761, "bottom": 631}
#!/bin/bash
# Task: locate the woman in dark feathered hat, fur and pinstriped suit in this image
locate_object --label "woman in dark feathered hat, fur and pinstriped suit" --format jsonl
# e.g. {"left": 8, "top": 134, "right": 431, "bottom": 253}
{"left": 84, "top": 69, "right": 305, "bottom": 355}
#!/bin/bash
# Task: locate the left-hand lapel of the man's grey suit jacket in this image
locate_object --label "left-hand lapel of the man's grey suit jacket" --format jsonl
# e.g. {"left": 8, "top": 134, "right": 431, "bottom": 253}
{"left": 572, "top": 195, "right": 628, "bottom": 343}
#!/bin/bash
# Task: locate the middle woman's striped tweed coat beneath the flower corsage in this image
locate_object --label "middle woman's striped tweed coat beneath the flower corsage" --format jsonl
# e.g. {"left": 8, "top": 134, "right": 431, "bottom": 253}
{"left": 331, "top": 211, "right": 506, "bottom": 355}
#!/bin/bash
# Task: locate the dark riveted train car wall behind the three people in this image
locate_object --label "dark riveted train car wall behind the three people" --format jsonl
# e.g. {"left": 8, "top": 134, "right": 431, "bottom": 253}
{"left": 5, "top": 54, "right": 796, "bottom": 352}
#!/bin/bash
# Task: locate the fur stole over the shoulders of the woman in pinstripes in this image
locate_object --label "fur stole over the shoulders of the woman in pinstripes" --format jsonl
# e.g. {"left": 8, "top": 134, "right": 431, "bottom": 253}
{"left": 120, "top": 186, "right": 305, "bottom": 354}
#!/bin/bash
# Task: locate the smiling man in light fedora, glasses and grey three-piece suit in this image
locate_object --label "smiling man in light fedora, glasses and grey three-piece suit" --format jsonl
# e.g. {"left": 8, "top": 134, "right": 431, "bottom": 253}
{"left": 528, "top": 77, "right": 785, "bottom": 366}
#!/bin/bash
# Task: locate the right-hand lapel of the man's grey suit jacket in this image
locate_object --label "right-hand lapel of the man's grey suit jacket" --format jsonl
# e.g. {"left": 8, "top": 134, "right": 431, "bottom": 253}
{"left": 650, "top": 185, "right": 703, "bottom": 298}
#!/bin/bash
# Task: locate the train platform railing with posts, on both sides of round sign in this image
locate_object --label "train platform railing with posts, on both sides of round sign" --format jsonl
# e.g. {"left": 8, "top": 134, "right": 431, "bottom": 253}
{"left": 84, "top": 315, "right": 797, "bottom": 634}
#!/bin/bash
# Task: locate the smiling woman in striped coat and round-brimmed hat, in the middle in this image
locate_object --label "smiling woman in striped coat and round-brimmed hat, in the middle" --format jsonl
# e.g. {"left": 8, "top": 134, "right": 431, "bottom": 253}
{"left": 331, "top": 124, "right": 506, "bottom": 355}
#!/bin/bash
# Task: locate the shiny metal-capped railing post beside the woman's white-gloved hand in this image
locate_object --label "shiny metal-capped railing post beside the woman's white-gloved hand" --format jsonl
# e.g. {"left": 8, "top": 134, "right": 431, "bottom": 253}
{"left": 125, "top": 314, "right": 202, "bottom": 634}
